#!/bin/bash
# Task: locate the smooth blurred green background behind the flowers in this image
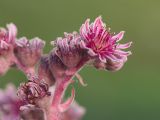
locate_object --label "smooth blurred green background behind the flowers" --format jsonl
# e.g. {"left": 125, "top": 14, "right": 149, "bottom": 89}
{"left": 0, "top": 0, "right": 160, "bottom": 120}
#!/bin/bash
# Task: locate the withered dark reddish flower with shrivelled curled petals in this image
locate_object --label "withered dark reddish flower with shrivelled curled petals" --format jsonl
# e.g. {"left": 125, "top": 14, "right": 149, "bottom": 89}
{"left": 18, "top": 77, "right": 51, "bottom": 104}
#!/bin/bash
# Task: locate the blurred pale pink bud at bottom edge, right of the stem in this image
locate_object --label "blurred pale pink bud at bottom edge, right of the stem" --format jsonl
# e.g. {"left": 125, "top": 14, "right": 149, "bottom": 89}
{"left": 62, "top": 102, "right": 86, "bottom": 120}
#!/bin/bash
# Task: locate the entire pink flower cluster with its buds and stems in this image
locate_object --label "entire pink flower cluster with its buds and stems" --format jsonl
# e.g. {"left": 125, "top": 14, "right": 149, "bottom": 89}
{"left": 0, "top": 17, "right": 131, "bottom": 120}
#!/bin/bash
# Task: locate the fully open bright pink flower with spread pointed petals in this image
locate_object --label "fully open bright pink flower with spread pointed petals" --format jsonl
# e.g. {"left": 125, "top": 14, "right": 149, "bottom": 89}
{"left": 80, "top": 17, "right": 131, "bottom": 63}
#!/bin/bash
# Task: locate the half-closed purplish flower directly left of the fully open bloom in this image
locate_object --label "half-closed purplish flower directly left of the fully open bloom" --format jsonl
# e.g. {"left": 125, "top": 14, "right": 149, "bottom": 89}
{"left": 54, "top": 32, "right": 85, "bottom": 68}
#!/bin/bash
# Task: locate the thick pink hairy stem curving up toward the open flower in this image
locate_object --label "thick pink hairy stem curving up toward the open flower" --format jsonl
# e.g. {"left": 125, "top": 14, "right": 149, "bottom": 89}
{"left": 50, "top": 58, "right": 89, "bottom": 120}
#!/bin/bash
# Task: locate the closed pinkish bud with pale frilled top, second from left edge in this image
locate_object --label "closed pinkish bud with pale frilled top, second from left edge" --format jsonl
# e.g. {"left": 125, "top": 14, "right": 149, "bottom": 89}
{"left": 15, "top": 37, "right": 45, "bottom": 73}
